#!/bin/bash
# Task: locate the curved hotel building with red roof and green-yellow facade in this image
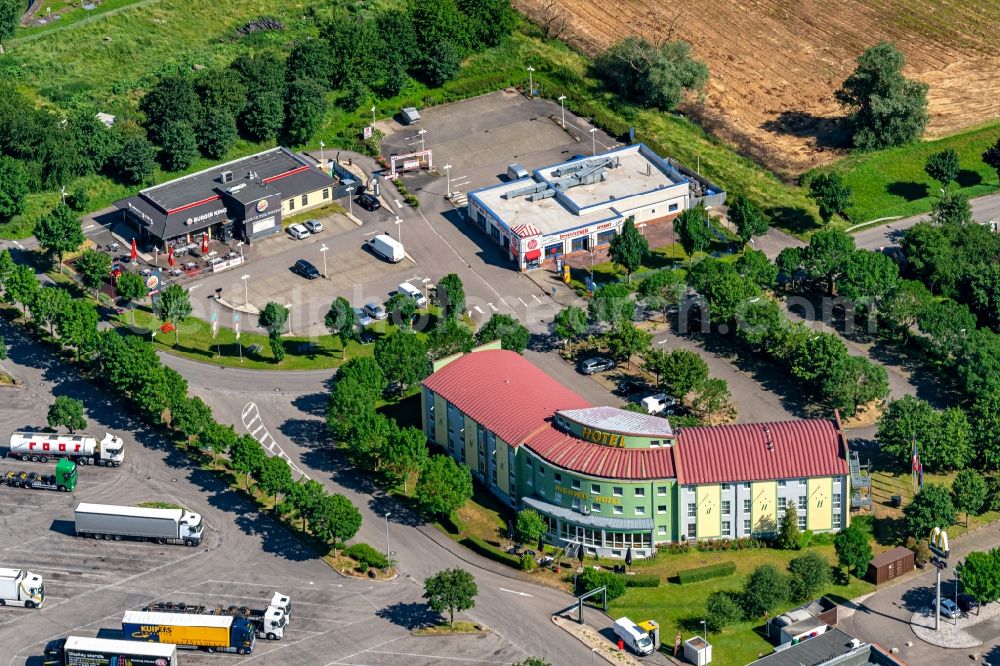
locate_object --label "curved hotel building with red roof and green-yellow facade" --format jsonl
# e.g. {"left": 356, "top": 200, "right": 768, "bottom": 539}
{"left": 421, "top": 348, "right": 850, "bottom": 557}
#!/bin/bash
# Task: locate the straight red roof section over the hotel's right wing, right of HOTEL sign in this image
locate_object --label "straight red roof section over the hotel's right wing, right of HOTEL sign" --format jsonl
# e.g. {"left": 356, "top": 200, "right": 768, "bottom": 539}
{"left": 676, "top": 419, "right": 848, "bottom": 484}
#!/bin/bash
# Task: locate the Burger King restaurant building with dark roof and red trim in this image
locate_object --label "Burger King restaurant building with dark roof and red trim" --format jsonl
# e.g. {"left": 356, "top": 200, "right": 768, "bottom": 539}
{"left": 115, "top": 147, "right": 334, "bottom": 250}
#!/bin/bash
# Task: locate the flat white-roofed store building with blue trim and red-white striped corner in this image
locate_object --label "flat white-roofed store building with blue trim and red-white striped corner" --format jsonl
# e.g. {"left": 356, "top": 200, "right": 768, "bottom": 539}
{"left": 468, "top": 144, "right": 726, "bottom": 271}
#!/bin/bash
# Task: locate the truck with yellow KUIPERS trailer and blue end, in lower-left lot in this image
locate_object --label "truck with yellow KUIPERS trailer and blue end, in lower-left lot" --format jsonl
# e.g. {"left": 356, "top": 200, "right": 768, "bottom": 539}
{"left": 122, "top": 611, "right": 257, "bottom": 654}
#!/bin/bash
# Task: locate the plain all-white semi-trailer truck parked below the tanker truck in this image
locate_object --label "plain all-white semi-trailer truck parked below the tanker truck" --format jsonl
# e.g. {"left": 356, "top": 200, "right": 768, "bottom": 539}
{"left": 75, "top": 502, "right": 204, "bottom": 546}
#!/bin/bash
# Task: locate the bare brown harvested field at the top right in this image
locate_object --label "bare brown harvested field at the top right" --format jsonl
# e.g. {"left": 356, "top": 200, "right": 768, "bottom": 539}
{"left": 515, "top": 0, "right": 1000, "bottom": 173}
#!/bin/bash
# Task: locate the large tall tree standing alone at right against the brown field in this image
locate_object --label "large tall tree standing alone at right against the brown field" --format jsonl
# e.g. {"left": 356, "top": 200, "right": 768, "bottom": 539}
{"left": 835, "top": 42, "right": 927, "bottom": 150}
